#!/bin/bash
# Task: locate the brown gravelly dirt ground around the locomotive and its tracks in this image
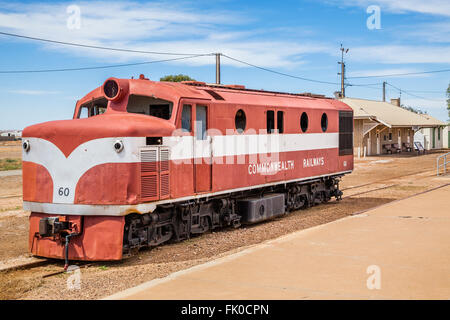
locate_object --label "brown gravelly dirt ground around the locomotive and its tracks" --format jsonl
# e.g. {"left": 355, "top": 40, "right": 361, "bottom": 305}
{"left": 0, "top": 151, "right": 450, "bottom": 299}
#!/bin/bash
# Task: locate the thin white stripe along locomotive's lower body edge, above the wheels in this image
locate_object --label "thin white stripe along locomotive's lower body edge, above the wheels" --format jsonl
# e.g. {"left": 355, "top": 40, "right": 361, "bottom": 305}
{"left": 23, "top": 170, "right": 352, "bottom": 216}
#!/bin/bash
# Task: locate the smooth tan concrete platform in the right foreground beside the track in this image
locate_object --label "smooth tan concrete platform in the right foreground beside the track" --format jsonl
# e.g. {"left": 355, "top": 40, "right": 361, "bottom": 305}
{"left": 107, "top": 185, "right": 450, "bottom": 299}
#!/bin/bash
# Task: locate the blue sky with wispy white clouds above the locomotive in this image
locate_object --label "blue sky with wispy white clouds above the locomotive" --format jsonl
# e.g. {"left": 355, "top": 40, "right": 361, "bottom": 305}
{"left": 0, "top": 0, "right": 450, "bottom": 130}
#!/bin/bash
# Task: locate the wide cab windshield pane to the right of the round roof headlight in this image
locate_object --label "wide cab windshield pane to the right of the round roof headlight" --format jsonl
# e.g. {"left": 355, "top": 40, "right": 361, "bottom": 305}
{"left": 127, "top": 95, "right": 173, "bottom": 120}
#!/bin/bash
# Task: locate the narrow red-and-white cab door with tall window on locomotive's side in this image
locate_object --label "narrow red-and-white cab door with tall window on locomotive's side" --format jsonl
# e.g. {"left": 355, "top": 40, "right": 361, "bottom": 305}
{"left": 194, "top": 105, "right": 212, "bottom": 192}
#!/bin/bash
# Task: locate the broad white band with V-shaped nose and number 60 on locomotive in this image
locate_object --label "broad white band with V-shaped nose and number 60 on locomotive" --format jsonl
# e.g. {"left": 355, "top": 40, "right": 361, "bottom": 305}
{"left": 22, "top": 133, "right": 339, "bottom": 203}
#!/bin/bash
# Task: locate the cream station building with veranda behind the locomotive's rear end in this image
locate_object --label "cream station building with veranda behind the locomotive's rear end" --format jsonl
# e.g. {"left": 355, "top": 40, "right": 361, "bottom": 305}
{"left": 340, "top": 98, "right": 447, "bottom": 157}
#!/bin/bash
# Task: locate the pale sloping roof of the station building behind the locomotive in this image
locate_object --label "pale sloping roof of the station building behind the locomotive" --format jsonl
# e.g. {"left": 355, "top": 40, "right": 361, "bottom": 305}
{"left": 340, "top": 98, "right": 447, "bottom": 127}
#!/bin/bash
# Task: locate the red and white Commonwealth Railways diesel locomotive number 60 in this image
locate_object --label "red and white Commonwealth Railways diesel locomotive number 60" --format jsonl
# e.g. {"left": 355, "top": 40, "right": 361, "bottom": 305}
{"left": 23, "top": 75, "right": 353, "bottom": 261}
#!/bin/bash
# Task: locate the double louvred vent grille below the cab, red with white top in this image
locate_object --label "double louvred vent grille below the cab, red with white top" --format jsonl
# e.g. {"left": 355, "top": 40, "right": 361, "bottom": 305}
{"left": 140, "top": 147, "right": 170, "bottom": 201}
